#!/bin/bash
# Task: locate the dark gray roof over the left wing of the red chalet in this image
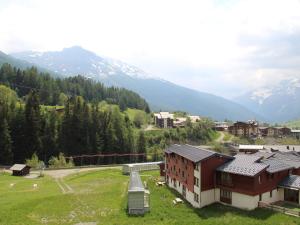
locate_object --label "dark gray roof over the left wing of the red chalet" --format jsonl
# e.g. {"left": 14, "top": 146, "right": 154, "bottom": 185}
{"left": 165, "top": 145, "right": 231, "bottom": 162}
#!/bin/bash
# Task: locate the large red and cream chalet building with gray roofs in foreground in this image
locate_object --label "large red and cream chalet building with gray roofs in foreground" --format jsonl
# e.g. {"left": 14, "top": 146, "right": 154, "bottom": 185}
{"left": 165, "top": 145, "right": 300, "bottom": 210}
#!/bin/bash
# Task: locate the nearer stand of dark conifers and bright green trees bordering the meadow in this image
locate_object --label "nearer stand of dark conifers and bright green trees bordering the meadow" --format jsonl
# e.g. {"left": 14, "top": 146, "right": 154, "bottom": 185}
{"left": 0, "top": 85, "right": 146, "bottom": 165}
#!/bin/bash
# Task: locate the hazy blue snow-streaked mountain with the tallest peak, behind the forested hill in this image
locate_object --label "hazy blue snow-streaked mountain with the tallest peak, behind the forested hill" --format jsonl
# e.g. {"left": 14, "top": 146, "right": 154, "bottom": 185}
{"left": 5, "top": 46, "right": 262, "bottom": 120}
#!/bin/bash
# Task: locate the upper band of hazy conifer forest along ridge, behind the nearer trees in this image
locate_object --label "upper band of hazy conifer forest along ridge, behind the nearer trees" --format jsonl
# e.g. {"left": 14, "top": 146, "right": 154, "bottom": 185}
{"left": 0, "top": 63, "right": 150, "bottom": 113}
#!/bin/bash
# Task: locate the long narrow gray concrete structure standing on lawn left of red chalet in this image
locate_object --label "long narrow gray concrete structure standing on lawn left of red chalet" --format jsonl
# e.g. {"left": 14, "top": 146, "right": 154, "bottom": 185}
{"left": 128, "top": 172, "right": 150, "bottom": 214}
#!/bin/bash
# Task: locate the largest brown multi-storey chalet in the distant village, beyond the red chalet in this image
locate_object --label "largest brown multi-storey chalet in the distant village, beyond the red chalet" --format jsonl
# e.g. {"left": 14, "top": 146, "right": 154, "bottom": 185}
{"left": 228, "top": 120, "right": 259, "bottom": 137}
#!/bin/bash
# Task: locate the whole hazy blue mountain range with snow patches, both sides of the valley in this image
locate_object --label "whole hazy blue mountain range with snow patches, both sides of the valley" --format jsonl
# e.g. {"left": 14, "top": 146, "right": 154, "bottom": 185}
{"left": 0, "top": 46, "right": 300, "bottom": 122}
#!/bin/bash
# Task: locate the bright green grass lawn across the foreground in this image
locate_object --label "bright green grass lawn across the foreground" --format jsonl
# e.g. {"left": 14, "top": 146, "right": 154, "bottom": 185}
{"left": 0, "top": 169, "right": 300, "bottom": 225}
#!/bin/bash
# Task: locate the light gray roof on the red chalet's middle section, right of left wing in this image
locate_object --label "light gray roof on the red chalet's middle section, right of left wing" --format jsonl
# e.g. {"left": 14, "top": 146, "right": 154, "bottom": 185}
{"left": 217, "top": 154, "right": 268, "bottom": 177}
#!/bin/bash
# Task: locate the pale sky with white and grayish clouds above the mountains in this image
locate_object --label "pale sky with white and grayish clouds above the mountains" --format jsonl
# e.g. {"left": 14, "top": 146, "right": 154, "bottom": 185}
{"left": 0, "top": 0, "right": 300, "bottom": 98}
